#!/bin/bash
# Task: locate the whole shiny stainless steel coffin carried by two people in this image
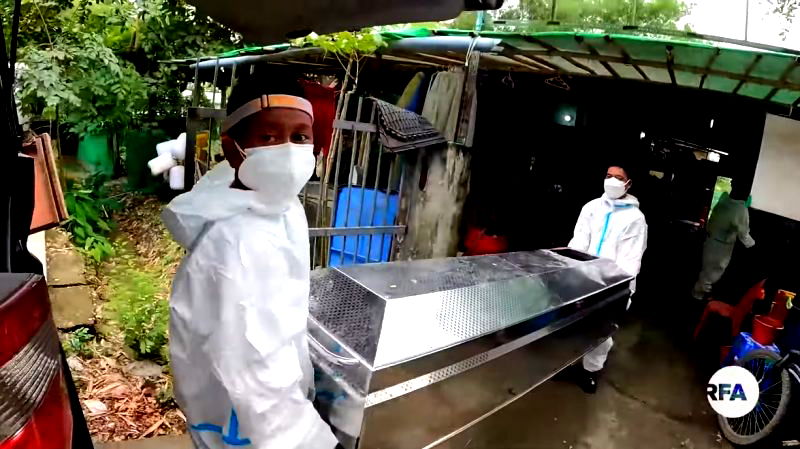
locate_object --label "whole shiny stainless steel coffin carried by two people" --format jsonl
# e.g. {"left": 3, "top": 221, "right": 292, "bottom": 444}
{"left": 309, "top": 250, "right": 632, "bottom": 448}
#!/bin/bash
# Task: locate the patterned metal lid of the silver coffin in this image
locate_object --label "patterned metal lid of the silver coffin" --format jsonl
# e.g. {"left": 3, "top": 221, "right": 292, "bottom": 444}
{"left": 310, "top": 250, "right": 632, "bottom": 370}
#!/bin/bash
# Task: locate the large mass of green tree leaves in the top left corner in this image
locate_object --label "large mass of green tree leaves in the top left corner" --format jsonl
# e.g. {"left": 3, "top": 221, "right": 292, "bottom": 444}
{"left": 8, "top": 0, "right": 240, "bottom": 134}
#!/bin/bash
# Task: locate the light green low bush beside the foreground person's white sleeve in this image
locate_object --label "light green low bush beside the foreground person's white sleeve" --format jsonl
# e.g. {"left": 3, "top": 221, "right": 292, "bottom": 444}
{"left": 108, "top": 265, "right": 169, "bottom": 361}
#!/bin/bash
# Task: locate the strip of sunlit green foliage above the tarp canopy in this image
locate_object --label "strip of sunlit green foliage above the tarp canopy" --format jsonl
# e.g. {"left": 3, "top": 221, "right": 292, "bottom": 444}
{"left": 500, "top": 0, "right": 688, "bottom": 31}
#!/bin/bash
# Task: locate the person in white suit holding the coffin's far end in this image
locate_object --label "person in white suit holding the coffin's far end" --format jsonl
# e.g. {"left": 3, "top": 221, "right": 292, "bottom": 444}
{"left": 569, "top": 166, "right": 647, "bottom": 393}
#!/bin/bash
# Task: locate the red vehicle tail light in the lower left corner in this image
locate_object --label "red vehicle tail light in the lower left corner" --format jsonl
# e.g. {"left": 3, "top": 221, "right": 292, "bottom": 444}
{"left": 0, "top": 273, "right": 72, "bottom": 449}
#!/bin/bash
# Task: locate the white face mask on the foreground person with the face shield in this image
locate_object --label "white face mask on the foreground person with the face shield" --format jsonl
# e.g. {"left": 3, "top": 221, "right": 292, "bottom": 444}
{"left": 239, "top": 142, "right": 316, "bottom": 204}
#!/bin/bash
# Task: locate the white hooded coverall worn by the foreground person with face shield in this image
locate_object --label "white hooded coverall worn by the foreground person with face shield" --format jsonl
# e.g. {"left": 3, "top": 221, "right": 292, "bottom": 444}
{"left": 163, "top": 163, "right": 337, "bottom": 449}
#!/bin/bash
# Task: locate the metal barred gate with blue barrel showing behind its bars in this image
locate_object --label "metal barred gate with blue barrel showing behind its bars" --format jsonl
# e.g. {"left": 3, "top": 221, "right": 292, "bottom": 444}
{"left": 300, "top": 93, "right": 406, "bottom": 269}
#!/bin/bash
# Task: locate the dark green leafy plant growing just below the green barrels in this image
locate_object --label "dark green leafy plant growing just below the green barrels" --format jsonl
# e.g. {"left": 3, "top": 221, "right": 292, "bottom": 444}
{"left": 64, "top": 175, "right": 120, "bottom": 263}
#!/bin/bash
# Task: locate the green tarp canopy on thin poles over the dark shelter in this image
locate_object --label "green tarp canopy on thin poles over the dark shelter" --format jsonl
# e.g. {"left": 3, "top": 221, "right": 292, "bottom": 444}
{"left": 175, "top": 29, "right": 800, "bottom": 107}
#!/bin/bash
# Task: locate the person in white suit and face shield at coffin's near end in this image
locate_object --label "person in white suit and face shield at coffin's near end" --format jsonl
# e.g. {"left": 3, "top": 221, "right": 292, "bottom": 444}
{"left": 163, "top": 74, "right": 337, "bottom": 449}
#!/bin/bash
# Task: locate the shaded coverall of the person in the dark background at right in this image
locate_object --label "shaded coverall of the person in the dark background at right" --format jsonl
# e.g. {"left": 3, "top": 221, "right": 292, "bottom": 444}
{"left": 692, "top": 193, "right": 756, "bottom": 299}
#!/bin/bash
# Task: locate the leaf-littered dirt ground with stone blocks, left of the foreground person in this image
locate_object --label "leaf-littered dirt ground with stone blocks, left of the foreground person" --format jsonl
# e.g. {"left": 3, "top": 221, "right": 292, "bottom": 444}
{"left": 53, "top": 181, "right": 186, "bottom": 442}
